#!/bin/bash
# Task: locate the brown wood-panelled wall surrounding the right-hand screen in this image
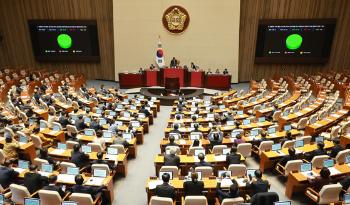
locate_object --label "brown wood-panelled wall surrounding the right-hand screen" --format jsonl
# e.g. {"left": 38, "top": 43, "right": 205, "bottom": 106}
{"left": 239, "top": 0, "right": 350, "bottom": 82}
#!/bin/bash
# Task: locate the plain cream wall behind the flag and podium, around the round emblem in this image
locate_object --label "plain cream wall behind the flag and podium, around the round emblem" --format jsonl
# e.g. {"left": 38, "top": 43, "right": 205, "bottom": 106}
{"left": 113, "top": 0, "right": 240, "bottom": 82}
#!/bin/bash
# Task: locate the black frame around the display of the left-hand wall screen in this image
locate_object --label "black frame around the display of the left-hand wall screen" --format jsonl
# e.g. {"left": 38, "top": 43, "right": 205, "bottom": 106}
{"left": 27, "top": 19, "right": 101, "bottom": 63}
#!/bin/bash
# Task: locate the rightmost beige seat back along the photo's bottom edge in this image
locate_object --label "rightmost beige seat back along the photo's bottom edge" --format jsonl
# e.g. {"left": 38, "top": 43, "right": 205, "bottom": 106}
{"left": 318, "top": 184, "right": 342, "bottom": 204}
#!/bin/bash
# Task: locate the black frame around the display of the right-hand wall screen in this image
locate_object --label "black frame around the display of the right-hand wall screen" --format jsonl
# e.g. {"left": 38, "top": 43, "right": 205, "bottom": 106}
{"left": 254, "top": 18, "right": 337, "bottom": 64}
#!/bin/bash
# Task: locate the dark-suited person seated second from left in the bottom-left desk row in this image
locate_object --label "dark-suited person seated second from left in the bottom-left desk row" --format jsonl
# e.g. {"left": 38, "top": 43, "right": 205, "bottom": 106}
{"left": 23, "top": 164, "right": 48, "bottom": 194}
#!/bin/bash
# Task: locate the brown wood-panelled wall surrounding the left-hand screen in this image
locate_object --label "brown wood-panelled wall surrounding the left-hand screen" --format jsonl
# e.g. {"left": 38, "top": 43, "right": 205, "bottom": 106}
{"left": 0, "top": 0, "right": 114, "bottom": 80}
